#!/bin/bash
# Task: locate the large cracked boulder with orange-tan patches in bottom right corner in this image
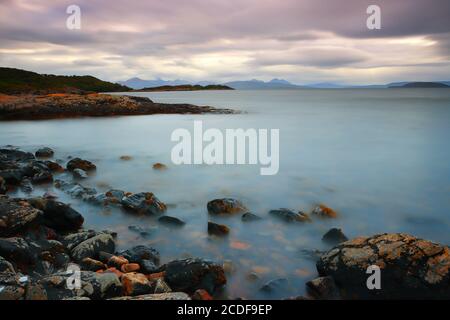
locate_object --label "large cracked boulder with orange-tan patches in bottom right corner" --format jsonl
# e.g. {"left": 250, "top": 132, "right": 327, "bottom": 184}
{"left": 316, "top": 233, "right": 450, "bottom": 299}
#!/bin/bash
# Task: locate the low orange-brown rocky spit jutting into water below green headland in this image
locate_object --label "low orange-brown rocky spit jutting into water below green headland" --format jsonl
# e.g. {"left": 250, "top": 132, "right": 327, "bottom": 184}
{"left": 0, "top": 93, "right": 237, "bottom": 120}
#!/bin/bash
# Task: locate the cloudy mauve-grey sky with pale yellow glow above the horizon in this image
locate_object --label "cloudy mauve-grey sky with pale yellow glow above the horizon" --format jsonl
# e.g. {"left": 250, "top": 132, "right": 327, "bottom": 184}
{"left": 0, "top": 0, "right": 450, "bottom": 84}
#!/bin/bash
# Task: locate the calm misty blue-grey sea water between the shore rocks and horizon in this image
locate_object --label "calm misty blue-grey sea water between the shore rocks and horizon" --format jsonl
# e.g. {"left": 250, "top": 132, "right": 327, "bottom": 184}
{"left": 0, "top": 89, "right": 450, "bottom": 298}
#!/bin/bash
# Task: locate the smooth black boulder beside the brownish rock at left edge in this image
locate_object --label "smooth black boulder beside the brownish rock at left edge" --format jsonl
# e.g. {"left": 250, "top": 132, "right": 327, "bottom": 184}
{"left": 29, "top": 198, "right": 84, "bottom": 231}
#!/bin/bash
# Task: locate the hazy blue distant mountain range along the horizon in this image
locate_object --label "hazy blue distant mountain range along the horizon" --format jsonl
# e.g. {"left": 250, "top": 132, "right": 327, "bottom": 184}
{"left": 118, "top": 78, "right": 450, "bottom": 90}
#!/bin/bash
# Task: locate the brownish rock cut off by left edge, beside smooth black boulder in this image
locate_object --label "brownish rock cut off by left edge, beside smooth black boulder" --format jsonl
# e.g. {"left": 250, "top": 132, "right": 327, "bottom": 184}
{"left": 0, "top": 196, "right": 43, "bottom": 237}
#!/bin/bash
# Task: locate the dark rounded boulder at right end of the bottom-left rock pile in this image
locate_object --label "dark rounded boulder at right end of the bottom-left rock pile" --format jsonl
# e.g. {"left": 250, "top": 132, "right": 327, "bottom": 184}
{"left": 163, "top": 259, "right": 227, "bottom": 294}
